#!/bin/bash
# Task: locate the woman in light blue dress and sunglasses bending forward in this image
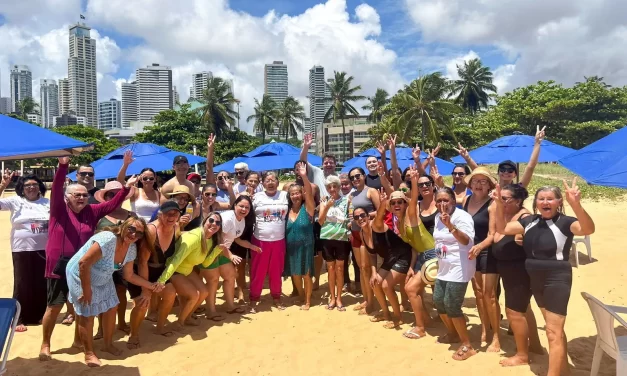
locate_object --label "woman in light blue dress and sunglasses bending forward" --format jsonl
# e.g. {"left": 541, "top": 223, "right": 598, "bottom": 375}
{"left": 66, "top": 217, "right": 163, "bottom": 367}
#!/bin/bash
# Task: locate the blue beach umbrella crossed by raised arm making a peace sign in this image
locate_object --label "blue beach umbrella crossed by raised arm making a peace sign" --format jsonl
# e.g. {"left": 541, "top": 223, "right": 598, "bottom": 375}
{"left": 451, "top": 135, "right": 575, "bottom": 164}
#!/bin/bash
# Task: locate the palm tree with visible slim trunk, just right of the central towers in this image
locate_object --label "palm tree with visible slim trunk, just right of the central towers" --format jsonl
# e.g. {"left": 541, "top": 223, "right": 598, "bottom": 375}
{"left": 324, "top": 72, "right": 366, "bottom": 161}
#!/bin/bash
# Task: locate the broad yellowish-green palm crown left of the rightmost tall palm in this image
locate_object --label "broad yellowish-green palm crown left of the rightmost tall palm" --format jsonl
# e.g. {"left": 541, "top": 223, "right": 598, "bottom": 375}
{"left": 392, "top": 72, "right": 462, "bottom": 150}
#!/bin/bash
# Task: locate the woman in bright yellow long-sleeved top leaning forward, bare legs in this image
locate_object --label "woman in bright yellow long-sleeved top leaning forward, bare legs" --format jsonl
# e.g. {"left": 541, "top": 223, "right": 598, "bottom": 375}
{"left": 158, "top": 212, "right": 224, "bottom": 332}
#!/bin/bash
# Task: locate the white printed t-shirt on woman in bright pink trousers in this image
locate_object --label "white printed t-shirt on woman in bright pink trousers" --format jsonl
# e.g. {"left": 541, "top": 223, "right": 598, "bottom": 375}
{"left": 253, "top": 191, "right": 287, "bottom": 242}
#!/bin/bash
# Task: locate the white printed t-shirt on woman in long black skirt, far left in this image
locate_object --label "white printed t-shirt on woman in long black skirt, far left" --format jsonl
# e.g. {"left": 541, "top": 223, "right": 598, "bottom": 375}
{"left": 0, "top": 196, "right": 50, "bottom": 252}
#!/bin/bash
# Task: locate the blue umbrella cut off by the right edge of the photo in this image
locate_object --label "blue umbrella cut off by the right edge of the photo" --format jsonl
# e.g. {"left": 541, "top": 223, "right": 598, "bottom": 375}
{"left": 558, "top": 127, "right": 627, "bottom": 189}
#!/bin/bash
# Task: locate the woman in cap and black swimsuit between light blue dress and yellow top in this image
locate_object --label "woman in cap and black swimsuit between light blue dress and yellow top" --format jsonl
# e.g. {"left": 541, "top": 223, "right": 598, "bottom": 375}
{"left": 127, "top": 201, "right": 181, "bottom": 349}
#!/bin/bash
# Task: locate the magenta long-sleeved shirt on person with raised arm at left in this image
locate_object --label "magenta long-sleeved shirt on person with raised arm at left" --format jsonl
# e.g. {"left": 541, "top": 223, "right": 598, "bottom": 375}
{"left": 46, "top": 164, "right": 129, "bottom": 278}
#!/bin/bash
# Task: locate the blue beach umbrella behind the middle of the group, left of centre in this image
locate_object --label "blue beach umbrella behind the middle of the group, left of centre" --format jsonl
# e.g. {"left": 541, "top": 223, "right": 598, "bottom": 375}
{"left": 213, "top": 142, "right": 322, "bottom": 173}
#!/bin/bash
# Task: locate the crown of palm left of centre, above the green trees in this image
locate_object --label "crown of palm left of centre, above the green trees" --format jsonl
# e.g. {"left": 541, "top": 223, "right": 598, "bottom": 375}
{"left": 196, "top": 77, "right": 239, "bottom": 138}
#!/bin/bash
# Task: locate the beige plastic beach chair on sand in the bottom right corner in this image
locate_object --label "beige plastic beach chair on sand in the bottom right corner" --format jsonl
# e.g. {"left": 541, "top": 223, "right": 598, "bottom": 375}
{"left": 581, "top": 292, "right": 627, "bottom": 376}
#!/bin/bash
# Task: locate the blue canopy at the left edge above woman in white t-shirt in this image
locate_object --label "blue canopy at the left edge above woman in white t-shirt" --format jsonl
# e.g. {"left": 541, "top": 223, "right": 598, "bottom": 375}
{"left": 0, "top": 115, "right": 94, "bottom": 161}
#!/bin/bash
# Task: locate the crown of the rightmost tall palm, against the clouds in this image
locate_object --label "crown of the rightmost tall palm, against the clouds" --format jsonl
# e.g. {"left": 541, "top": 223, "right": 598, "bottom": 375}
{"left": 449, "top": 58, "right": 496, "bottom": 115}
